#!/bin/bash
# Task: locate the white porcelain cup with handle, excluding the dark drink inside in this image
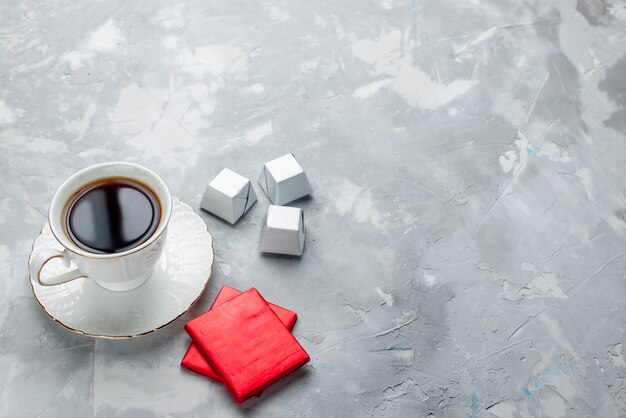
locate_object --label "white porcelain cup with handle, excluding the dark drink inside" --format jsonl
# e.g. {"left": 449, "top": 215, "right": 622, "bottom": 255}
{"left": 30, "top": 162, "right": 172, "bottom": 292}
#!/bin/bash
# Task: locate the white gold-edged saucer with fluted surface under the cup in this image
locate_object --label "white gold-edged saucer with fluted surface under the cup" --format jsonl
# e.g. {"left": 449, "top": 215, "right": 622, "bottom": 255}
{"left": 28, "top": 197, "right": 213, "bottom": 338}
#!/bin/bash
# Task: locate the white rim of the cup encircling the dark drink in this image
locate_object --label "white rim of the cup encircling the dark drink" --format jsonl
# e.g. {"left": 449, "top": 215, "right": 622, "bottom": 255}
{"left": 48, "top": 161, "right": 172, "bottom": 259}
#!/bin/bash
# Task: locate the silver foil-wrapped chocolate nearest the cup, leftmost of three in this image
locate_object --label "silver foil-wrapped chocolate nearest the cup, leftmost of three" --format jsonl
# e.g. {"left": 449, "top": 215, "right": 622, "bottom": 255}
{"left": 200, "top": 168, "right": 257, "bottom": 224}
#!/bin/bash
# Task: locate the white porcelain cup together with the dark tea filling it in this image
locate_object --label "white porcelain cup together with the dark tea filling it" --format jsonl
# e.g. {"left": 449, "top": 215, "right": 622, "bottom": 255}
{"left": 30, "top": 162, "right": 172, "bottom": 291}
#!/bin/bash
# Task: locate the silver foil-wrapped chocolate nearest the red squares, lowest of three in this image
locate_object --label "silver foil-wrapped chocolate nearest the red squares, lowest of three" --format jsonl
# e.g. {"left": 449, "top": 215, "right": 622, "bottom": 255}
{"left": 259, "top": 205, "right": 305, "bottom": 256}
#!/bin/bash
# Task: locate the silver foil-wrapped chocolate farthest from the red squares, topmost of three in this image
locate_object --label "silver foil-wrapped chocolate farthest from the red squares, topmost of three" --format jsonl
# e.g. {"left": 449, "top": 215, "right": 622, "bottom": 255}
{"left": 259, "top": 154, "right": 312, "bottom": 205}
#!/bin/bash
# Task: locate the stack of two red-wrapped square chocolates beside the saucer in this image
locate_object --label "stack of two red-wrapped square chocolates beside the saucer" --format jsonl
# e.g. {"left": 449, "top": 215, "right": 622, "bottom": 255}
{"left": 181, "top": 286, "right": 309, "bottom": 403}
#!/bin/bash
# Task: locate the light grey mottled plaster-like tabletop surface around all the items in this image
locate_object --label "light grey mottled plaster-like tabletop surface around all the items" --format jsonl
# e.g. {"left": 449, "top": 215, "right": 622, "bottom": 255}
{"left": 0, "top": 0, "right": 626, "bottom": 417}
